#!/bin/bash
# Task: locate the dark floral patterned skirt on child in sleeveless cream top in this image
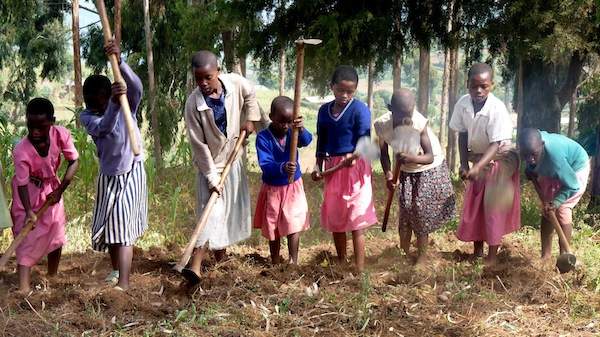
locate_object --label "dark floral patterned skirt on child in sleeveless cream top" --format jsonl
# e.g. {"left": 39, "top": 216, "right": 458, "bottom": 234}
{"left": 398, "top": 162, "right": 456, "bottom": 235}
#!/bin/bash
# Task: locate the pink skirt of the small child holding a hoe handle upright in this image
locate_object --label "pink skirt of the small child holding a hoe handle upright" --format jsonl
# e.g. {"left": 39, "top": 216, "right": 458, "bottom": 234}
{"left": 254, "top": 178, "right": 310, "bottom": 241}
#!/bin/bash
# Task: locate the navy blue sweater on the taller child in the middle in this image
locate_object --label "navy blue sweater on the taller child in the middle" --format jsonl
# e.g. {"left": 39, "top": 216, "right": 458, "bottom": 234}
{"left": 317, "top": 98, "right": 371, "bottom": 157}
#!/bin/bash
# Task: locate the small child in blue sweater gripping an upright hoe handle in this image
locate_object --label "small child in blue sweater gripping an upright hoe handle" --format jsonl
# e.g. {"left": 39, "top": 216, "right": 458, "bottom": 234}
{"left": 254, "top": 96, "right": 312, "bottom": 264}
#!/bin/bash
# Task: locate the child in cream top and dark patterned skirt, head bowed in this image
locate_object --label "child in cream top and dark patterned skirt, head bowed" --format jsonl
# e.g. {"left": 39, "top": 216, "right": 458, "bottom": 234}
{"left": 375, "top": 89, "right": 455, "bottom": 264}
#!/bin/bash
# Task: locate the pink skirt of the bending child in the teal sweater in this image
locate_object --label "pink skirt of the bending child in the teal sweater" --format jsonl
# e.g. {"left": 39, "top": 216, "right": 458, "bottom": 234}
{"left": 538, "top": 164, "right": 590, "bottom": 224}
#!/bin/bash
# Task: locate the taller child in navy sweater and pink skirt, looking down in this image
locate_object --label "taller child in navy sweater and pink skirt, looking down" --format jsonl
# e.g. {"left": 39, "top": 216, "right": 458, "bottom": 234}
{"left": 312, "top": 66, "right": 377, "bottom": 272}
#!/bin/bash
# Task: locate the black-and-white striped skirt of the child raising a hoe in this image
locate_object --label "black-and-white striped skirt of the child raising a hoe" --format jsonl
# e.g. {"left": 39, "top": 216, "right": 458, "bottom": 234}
{"left": 92, "top": 161, "right": 148, "bottom": 251}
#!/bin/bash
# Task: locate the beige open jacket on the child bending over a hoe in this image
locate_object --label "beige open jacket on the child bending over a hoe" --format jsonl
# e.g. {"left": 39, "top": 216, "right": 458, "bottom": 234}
{"left": 184, "top": 73, "right": 261, "bottom": 187}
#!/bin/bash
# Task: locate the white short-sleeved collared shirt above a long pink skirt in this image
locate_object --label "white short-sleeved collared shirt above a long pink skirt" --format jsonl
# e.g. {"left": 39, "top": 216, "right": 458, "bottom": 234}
{"left": 450, "top": 93, "right": 513, "bottom": 154}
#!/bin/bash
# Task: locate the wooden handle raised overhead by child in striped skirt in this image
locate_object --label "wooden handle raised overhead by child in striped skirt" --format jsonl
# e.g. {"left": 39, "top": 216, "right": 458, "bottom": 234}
{"left": 96, "top": 0, "right": 141, "bottom": 156}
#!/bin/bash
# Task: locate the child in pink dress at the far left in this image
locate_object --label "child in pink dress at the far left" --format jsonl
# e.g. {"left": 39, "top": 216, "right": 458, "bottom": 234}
{"left": 11, "top": 98, "right": 79, "bottom": 293}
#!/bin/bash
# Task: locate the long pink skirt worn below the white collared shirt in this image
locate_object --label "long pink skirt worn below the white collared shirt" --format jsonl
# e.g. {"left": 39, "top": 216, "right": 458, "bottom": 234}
{"left": 456, "top": 152, "right": 521, "bottom": 246}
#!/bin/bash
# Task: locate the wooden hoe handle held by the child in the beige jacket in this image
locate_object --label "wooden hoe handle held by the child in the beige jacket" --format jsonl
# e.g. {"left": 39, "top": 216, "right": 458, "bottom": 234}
{"left": 173, "top": 130, "right": 246, "bottom": 273}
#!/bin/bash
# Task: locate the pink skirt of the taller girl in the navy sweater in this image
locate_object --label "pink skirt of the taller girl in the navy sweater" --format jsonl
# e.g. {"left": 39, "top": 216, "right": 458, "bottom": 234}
{"left": 321, "top": 156, "right": 377, "bottom": 233}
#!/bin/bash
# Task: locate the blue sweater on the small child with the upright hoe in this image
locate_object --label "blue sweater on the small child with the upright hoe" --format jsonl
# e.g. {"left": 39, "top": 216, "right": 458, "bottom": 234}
{"left": 256, "top": 128, "right": 312, "bottom": 186}
